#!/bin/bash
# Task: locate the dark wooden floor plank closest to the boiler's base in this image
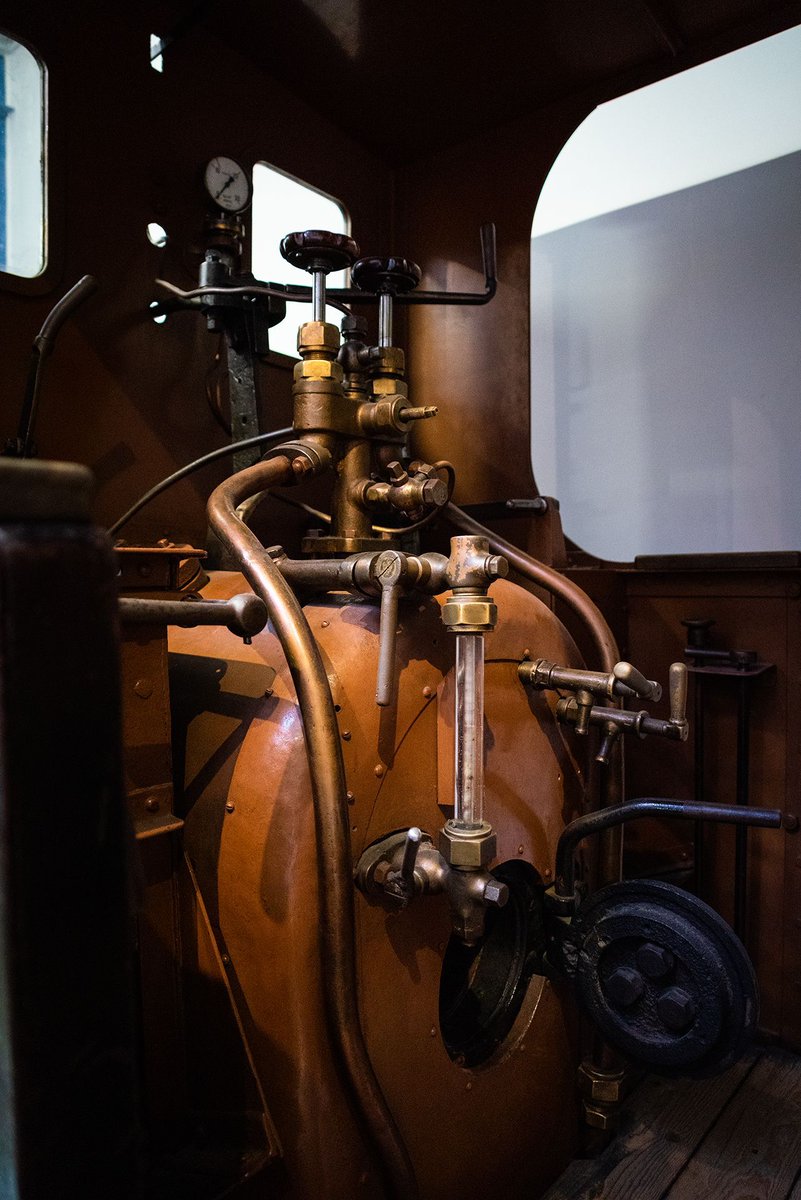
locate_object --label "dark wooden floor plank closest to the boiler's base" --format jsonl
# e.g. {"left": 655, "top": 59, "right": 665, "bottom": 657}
{"left": 543, "top": 1056, "right": 754, "bottom": 1200}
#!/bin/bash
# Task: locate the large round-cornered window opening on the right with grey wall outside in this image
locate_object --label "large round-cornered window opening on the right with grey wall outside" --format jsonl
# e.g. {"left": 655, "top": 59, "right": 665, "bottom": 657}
{"left": 531, "top": 29, "right": 801, "bottom": 560}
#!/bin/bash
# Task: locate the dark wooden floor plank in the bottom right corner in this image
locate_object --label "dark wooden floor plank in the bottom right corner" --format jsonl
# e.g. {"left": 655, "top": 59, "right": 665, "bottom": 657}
{"left": 666, "top": 1054, "right": 801, "bottom": 1200}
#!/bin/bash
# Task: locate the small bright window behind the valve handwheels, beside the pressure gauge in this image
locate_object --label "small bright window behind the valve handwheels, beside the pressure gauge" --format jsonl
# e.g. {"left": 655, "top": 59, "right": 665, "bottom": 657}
{"left": 251, "top": 162, "right": 349, "bottom": 358}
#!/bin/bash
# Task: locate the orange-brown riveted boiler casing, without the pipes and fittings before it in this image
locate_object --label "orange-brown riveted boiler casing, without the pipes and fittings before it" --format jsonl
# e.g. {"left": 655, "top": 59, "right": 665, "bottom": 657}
{"left": 169, "top": 572, "right": 585, "bottom": 1200}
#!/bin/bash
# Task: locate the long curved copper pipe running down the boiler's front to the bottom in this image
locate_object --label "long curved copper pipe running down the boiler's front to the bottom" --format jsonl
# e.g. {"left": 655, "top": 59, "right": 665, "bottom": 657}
{"left": 207, "top": 450, "right": 418, "bottom": 1200}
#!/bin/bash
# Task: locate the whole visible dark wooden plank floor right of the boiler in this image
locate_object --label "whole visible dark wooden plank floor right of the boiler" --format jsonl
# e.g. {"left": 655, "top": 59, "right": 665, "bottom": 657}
{"left": 543, "top": 1050, "right": 801, "bottom": 1200}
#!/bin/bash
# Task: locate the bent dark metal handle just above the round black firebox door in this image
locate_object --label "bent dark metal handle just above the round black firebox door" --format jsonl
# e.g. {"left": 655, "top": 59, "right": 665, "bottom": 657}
{"left": 555, "top": 797, "right": 782, "bottom": 896}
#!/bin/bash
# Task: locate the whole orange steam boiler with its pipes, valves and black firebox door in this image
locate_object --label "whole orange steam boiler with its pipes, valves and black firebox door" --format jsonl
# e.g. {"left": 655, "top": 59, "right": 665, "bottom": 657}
{"left": 112, "top": 227, "right": 781, "bottom": 1200}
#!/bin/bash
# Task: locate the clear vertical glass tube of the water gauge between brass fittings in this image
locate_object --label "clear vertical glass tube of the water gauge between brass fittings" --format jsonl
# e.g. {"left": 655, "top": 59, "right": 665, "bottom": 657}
{"left": 453, "top": 634, "right": 484, "bottom": 829}
